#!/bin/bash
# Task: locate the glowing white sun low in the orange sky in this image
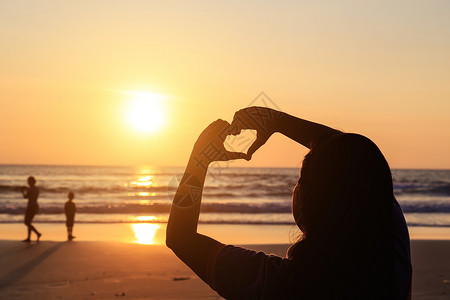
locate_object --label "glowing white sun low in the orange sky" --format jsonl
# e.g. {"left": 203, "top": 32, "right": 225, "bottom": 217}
{"left": 127, "top": 91, "right": 165, "bottom": 133}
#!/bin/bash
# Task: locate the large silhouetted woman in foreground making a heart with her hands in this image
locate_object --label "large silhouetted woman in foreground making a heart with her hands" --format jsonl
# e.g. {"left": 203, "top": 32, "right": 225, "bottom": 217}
{"left": 166, "top": 107, "right": 412, "bottom": 299}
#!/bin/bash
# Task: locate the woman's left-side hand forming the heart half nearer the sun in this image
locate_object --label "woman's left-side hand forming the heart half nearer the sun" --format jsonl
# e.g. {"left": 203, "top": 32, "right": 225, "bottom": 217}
{"left": 192, "top": 119, "right": 246, "bottom": 167}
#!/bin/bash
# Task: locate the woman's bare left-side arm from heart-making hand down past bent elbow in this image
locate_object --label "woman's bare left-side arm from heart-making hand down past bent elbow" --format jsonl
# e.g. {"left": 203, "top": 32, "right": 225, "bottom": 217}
{"left": 166, "top": 120, "right": 244, "bottom": 282}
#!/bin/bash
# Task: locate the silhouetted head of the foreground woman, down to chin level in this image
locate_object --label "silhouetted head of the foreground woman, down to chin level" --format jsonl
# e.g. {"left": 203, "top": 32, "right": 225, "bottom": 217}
{"left": 292, "top": 134, "right": 393, "bottom": 239}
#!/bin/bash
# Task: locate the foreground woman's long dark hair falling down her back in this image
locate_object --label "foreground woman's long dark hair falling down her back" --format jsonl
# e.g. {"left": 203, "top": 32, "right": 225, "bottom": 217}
{"left": 289, "top": 133, "right": 394, "bottom": 298}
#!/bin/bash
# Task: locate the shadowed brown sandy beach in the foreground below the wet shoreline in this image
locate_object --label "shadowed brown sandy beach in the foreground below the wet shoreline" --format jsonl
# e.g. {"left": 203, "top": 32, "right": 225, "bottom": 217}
{"left": 0, "top": 224, "right": 450, "bottom": 299}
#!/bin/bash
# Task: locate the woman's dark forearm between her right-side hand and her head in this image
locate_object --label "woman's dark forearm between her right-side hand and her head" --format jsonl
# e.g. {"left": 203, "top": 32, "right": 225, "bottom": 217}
{"left": 276, "top": 113, "right": 341, "bottom": 148}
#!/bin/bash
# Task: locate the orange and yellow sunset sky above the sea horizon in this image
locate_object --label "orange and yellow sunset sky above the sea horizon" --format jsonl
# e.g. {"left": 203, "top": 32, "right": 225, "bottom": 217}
{"left": 0, "top": 0, "right": 450, "bottom": 168}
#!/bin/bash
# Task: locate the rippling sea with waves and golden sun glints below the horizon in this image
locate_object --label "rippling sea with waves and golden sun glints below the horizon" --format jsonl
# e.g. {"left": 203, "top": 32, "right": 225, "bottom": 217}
{"left": 0, "top": 165, "right": 450, "bottom": 227}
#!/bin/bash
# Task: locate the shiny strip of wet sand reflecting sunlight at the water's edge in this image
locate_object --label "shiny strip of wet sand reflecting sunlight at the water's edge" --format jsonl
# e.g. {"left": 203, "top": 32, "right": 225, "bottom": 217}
{"left": 0, "top": 223, "right": 450, "bottom": 245}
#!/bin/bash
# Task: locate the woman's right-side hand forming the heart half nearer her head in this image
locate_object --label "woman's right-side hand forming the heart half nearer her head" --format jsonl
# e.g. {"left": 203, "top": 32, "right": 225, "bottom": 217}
{"left": 230, "top": 106, "right": 283, "bottom": 160}
